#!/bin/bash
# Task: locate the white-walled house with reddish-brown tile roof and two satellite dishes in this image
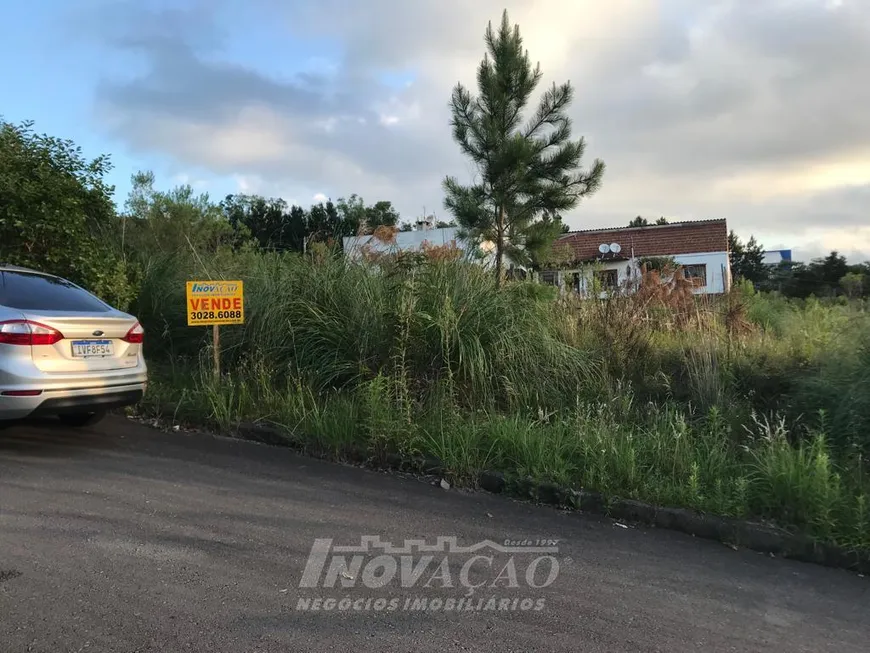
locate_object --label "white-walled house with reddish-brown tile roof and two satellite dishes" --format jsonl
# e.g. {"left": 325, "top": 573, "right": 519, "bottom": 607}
{"left": 540, "top": 220, "right": 731, "bottom": 296}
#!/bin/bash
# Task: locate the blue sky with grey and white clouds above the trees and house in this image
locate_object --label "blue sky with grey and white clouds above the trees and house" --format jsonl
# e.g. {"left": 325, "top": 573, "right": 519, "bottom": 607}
{"left": 0, "top": 0, "right": 870, "bottom": 260}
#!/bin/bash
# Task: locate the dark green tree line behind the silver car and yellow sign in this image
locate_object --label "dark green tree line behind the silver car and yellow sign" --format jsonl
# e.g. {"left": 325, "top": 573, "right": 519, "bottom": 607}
{"left": 0, "top": 117, "right": 412, "bottom": 306}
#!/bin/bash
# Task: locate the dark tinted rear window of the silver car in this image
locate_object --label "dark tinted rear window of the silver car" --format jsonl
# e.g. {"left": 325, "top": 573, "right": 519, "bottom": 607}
{"left": 0, "top": 270, "right": 111, "bottom": 313}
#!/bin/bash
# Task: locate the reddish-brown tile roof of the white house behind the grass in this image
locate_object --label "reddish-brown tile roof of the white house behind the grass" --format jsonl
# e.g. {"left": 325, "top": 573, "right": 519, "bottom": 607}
{"left": 560, "top": 220, "right": 728, "bottom": 261}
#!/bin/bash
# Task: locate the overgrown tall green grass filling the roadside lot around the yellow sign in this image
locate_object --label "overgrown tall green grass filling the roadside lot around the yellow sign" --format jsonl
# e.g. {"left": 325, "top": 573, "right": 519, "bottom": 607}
{"left": 138, "top": 252, "right": 870, "bottom": 548}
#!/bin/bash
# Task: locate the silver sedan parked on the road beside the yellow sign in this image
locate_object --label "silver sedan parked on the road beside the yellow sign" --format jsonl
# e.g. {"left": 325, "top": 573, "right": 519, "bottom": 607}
{"left": 0, "top": 263, "right": 147, "bottom": 426}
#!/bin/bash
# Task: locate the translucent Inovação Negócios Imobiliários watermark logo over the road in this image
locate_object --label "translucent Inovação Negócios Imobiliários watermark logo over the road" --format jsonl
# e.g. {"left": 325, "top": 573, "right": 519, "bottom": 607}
{"left": 296, "top": 535, "right": 559, "bottom": 612}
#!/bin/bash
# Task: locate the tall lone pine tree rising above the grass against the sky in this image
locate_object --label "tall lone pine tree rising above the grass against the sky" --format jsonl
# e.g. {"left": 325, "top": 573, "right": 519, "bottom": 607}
{"left": 444, "top": 11, "right": 604, "bottom": 285}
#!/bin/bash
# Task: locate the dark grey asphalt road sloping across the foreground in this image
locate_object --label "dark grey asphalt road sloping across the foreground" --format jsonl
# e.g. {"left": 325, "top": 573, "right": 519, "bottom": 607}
{"left": 0, "top": 418, "right": 870, "bottom": 653}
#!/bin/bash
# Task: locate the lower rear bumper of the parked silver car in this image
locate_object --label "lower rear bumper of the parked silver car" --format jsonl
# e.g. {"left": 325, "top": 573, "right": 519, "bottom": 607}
{"left": 0, "top": 381, "right": 146, "bottom": 420}
